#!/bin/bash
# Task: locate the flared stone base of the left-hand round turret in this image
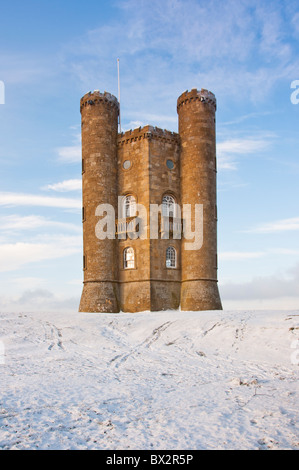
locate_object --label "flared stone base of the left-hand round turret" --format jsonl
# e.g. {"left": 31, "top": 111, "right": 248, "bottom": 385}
{"left": 79, "top": 281, "right": 119, "bottom": 313}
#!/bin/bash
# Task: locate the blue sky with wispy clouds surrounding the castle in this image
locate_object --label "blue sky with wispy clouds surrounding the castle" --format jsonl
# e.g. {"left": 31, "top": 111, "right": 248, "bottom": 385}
{"left": 0, "top": 0, "right": 299, "bottom": 311}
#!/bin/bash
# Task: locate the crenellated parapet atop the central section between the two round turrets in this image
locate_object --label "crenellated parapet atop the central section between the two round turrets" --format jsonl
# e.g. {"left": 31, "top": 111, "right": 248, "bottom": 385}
{"left": 118, "top": 125, "right": 180, "bottom": 145}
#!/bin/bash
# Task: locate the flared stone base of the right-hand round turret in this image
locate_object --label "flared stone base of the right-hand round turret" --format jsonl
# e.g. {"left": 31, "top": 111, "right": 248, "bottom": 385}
{"left": 181, "top": 280, "right": 222, "bottom": 311}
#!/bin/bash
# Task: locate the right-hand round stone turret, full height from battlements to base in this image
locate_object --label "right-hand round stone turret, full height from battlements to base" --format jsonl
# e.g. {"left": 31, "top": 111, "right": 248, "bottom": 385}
{"left": 177, "top": 90, "right": 221, "bottom": 310}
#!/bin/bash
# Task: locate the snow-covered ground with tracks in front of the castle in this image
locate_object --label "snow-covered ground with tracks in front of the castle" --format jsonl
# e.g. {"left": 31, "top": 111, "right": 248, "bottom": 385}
{"left": 0, "top": 311, "right": 299, "bottom": 450}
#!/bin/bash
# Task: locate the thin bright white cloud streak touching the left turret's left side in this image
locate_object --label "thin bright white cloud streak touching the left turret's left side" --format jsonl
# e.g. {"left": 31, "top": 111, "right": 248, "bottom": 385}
{"left": 0, "top": 192, "right": 82, "bottom": 209}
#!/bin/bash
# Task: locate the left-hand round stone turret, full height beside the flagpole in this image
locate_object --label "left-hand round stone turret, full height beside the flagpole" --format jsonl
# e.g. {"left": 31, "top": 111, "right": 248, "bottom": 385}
{"left": 79, "top": 91, "right": 119, "bottom": 312}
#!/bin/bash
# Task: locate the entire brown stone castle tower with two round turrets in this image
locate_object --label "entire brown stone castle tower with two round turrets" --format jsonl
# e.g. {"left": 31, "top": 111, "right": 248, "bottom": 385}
{"left": 79, "top": 90, "right": 222, "bottom": 312}
